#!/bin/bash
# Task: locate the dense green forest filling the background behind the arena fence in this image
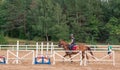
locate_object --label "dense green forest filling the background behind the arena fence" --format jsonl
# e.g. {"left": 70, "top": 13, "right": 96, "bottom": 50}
{"left": 0, "top": 0, "right": 120, "bottom": 44}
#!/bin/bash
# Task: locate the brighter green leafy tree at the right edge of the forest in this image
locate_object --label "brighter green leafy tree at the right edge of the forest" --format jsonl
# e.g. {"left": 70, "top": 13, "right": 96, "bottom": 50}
{"left": 106, "top": 17, "right": 120, "bottom": 44}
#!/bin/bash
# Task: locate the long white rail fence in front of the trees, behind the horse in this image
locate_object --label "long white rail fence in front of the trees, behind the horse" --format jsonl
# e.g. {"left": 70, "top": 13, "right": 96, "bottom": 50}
{"left": 0, "top": 44, "right": 120, "bottom": 51}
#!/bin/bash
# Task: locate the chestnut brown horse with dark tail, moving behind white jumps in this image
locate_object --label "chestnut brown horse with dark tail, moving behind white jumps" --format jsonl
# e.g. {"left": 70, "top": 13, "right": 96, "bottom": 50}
{"left": 58, "top": 40, "right": 93, "bottom": 59}
